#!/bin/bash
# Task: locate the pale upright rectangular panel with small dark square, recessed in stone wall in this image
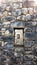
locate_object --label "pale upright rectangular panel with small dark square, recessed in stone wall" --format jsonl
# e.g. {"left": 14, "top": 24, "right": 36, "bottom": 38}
{"left": 14, "top": 28, "right": 24, "bottom": 45}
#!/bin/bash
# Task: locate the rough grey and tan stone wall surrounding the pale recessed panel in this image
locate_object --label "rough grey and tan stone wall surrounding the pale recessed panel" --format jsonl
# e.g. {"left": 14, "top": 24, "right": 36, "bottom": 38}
{"left": 0, "top": 0, "right": 37, "bottom": 65}
